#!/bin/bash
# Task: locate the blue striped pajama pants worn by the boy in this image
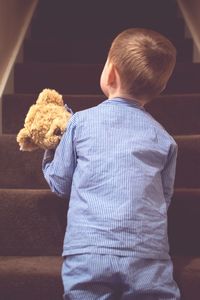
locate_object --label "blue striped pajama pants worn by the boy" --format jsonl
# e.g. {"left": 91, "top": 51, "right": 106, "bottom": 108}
{"left": 62, "top": 254, "right": 180, "bottom": 300}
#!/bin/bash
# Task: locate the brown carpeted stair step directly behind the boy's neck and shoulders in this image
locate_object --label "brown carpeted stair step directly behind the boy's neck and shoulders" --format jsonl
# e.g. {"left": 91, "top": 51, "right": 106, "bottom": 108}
{"left": 2, "top": 94, "right": 200, "bottom": 135}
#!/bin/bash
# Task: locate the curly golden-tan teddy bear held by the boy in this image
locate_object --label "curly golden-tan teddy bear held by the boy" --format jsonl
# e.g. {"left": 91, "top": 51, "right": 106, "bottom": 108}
{"left": 17, "top": 89, "right": 72, "bottom": 151}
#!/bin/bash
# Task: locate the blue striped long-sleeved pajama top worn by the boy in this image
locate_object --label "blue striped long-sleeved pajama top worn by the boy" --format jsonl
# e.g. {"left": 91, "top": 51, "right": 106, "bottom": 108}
{"left": 43, "top": 98, "right": 177, "bottom": 259}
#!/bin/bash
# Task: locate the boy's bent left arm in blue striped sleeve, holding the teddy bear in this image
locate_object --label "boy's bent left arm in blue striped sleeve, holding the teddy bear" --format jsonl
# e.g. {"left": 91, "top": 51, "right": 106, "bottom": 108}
{"left": 42, "top": 117, "right": 76, "bottom": 197}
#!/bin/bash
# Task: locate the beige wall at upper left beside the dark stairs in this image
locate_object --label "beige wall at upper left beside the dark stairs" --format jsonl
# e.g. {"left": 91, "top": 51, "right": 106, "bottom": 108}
{"left": 0, "top": 0, "right": 38, "bottom": 132}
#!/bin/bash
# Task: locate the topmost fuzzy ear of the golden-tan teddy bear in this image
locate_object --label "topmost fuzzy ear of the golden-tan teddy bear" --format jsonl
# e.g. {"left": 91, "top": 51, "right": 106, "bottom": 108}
{"left": 36, "top": 89, "right": 64, "bottom": 106}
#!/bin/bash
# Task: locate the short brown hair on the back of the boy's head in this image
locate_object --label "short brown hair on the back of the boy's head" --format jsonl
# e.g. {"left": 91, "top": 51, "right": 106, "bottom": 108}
{"left": 108, "top": 28, "right": 176, "bottom": 101}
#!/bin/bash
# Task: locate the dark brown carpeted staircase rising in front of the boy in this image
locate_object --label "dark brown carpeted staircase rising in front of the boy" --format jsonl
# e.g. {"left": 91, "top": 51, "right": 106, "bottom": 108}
{"left": 0, "top": 0, "right": 200, "bottom": 300}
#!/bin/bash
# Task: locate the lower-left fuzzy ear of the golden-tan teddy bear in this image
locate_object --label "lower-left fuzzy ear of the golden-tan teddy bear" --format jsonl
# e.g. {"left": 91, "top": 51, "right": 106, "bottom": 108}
{"left": 17, "top": 128, "right": 38, "bottom": 151}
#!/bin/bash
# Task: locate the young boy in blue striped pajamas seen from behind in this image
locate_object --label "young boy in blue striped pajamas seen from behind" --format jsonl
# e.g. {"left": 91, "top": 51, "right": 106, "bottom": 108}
{"left": 43, "top": 28, "right": 180, "bottom": 300}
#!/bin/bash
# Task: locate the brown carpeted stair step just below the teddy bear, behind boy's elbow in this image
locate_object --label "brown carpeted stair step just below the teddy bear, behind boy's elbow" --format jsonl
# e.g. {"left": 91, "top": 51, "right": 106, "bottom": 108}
{"left": 0, "top": 135, "right": 200, "bottom": 189}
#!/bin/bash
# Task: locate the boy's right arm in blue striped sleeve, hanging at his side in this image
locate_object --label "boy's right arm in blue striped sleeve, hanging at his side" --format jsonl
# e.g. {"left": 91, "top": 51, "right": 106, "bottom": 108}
{"left": 161, "top": 144, "right": 178, "bottom": 208}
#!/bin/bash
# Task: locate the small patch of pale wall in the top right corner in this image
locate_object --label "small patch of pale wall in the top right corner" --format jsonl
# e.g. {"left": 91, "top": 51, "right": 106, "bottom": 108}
{"left": 177, "top": 0, "right": 200, "bottom": 62}
